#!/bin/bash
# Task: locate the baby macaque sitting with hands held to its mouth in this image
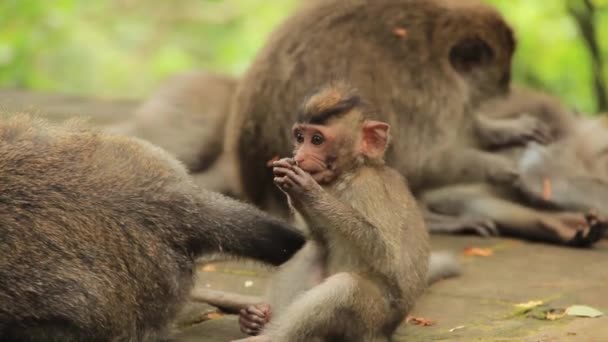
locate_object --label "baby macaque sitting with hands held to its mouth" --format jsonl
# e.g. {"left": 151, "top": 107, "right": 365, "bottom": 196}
{"left": 232, "top": 82, "right": 430, "bottom": 342}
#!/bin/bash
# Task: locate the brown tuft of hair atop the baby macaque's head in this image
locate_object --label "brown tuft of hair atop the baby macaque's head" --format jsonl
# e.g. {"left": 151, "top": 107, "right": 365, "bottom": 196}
{"left": 297, "top": 80, "right": 364, "bottom": 125}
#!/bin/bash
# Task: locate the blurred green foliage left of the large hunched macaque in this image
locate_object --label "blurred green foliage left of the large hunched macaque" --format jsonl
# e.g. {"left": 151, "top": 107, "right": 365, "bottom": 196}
{"left": 0, "top": 0, "right": 297, "bottom": 97}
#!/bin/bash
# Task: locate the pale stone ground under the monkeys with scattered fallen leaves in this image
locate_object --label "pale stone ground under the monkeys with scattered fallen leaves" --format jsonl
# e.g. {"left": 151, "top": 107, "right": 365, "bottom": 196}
{"left": 0, "top": 90, "right": 608, "bottom": 342}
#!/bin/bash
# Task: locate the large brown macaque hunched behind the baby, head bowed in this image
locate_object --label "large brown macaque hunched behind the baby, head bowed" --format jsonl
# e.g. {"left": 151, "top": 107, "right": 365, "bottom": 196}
{"left": 225, "top": 0, "right": 528, "bottom": 213}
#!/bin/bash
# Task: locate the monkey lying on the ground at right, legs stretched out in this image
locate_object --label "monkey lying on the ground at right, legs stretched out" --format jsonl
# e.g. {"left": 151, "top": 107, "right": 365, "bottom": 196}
{"left": 420, "top": 88, "right": 608, "bottom": 246}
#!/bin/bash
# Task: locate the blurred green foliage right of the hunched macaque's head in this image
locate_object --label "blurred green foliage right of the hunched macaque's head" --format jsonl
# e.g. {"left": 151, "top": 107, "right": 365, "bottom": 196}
{"left": 488, "top": 0, "right": 608, "bottom": 112}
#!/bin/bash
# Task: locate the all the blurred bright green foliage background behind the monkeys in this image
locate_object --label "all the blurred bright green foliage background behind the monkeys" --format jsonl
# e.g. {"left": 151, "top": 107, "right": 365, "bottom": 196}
{"left": 0, "top": 0, "right": 608, "bottom": 113}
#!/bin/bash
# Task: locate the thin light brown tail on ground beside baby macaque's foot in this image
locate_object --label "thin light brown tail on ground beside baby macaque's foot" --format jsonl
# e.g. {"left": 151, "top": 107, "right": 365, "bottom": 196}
{"left": 190, "top": 288, "right": 262, "bottom": 314}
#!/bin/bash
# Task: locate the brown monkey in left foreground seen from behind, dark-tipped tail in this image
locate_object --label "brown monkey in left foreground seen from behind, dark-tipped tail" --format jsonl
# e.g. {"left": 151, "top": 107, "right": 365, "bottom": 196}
{"left": 0, "top": 115, "right": 305, "bottom": 341}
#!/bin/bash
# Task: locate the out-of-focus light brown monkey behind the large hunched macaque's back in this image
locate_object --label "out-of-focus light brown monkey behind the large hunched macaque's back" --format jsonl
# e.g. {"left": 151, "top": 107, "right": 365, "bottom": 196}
{"left": 106, "top": 71, "right": 240, "bottom": 196}
